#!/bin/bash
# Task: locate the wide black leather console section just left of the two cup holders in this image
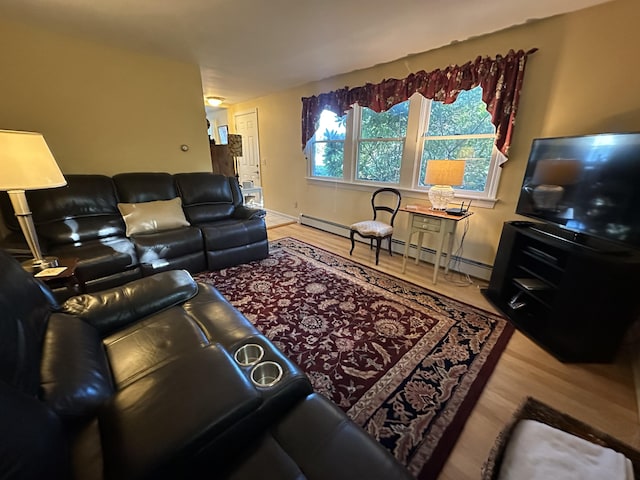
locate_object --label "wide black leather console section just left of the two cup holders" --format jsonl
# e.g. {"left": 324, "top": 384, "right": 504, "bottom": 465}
{"left": 99, "top": 345, "right": 261, "bottom": 480}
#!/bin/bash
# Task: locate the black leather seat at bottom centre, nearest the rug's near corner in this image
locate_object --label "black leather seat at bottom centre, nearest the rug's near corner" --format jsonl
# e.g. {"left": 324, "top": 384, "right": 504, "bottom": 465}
{"left": 221, "top": 393, "right": 413, "bottom": 480}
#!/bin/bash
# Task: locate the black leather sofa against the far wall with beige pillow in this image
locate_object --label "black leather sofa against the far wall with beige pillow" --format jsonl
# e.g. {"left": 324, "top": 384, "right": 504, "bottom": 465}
{"left": 0, "top": 172, "right": 269, "bottom": 292}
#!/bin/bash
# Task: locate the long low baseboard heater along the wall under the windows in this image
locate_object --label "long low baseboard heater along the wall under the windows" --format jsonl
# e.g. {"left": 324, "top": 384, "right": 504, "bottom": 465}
{"left": 299, "top": 213, "right": 491, "bottom": 280}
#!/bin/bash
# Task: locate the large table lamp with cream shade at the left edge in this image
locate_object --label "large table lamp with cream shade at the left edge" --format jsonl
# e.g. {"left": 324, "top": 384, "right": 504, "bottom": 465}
{"left": 0, "top": 130, "right": 67, "bottom": 270}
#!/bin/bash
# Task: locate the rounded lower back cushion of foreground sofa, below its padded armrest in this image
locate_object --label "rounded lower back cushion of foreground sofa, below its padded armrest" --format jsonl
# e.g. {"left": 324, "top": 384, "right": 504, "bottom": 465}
{"left": 40, "top": 313, "right": 114, "bottom": 420}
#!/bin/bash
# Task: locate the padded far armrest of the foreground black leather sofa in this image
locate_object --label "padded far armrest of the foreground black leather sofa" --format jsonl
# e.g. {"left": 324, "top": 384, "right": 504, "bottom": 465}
{"left": 61, "top": 270, "right": 198, "bottom": 336}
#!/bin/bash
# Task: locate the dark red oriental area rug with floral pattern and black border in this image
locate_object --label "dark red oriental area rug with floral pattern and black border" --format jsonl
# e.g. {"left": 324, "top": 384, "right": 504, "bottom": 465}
{"left": 195, "top": 238, "right": 513, "bottom": 479}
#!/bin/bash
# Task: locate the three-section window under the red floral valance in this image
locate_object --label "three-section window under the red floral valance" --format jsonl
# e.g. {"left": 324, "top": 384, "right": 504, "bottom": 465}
{"left": 310, "top": 87, "right": 500, "bottom": 203}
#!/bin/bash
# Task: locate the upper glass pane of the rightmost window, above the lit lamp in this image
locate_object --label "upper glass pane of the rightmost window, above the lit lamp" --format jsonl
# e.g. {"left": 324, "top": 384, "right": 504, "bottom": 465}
{"left": 425, "top": 87, "right": 496, "bottom": 137}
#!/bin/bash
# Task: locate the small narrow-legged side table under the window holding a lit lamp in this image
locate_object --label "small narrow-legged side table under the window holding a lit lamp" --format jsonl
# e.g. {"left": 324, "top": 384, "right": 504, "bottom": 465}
{"left": 400, "top": 205, "right": 473, "bottom": 284}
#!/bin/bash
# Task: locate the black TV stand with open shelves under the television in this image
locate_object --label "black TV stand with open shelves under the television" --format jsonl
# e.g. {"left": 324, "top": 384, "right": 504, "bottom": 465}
{"left": 482, "top": 222, "right": 640, "bottom": 362}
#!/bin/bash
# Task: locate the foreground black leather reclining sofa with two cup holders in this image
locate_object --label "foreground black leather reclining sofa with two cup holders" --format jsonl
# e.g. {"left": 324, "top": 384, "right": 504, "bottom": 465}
{"left": 0, "top": 251, "right": 411, "bottom": 480}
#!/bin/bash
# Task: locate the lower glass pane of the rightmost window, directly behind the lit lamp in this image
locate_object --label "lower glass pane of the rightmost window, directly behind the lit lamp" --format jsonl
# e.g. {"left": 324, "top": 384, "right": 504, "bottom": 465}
{"left": 419, "top": 138, "right": 494, "bottom": 192}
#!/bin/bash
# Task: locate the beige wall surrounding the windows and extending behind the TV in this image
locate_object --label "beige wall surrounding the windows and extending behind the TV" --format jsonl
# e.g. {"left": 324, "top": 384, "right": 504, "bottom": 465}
{"left": 230, "top": 0, "right": 640, "bottom": 265}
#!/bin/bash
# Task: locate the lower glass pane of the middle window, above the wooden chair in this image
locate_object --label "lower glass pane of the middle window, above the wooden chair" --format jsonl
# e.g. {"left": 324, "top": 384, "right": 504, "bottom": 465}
{"left": 356, "top": 141, "right": 404, "bottom": 183}
